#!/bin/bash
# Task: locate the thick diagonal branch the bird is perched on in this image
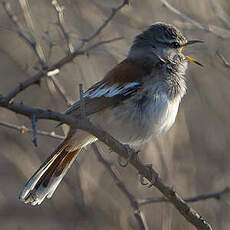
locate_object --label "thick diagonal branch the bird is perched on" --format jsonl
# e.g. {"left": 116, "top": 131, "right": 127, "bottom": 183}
{"left": 0, "top": 99, "right": 212, "bottom": 230}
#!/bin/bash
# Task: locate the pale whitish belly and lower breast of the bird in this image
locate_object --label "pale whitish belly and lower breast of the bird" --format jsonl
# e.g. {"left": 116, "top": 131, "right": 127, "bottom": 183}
{"left": 95, "top": 85, "right": 180, "bottom": 145}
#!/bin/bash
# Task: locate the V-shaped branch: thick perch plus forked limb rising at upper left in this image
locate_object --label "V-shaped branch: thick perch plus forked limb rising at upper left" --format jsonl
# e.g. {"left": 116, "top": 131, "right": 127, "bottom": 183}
{"left": 0, "top": 0, "right": 212, "bottom": 230}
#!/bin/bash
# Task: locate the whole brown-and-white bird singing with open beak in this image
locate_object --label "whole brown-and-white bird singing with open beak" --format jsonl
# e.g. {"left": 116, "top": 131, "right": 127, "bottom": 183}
{"left": 19, "top": 22, "right": 203, "bottom": 205}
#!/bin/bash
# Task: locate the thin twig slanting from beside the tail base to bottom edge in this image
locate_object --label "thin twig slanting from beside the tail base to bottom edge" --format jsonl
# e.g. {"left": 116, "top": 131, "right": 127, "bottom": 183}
{"left": 91, "top": 143, "right": 148, "bottom": 230}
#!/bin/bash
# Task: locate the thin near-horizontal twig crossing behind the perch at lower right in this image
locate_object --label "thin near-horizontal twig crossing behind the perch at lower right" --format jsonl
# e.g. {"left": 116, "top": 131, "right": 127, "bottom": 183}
{"left": 138, "top": 187, "right": 230, "bottom": 206}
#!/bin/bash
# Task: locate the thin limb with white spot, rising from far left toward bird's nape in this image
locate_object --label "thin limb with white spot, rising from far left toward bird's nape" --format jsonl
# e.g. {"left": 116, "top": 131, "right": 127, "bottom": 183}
{"left": 4, "top": 37, "right": 122, "bottom": 103}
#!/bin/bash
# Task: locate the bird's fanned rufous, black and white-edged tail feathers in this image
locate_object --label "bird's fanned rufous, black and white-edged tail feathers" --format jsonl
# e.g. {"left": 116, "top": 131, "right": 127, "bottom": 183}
{"left": 19, "top": 143, "right": 81, "bottom": 205}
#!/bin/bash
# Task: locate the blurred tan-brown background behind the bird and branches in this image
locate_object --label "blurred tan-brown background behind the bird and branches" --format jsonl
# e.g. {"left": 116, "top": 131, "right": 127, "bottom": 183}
{"left": 0, "top": 0, "right": 230, "bottom": 230}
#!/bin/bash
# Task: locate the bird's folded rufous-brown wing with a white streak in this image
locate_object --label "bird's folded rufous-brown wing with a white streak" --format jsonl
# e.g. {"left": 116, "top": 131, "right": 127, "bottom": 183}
{"left": 65, "top": 59, "right": 149, "bottom": 116}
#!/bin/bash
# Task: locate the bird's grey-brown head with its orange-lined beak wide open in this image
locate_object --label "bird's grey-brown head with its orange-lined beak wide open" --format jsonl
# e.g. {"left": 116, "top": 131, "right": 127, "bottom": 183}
{"left": 129, "top": 23, "right": 203, "bottom": 66}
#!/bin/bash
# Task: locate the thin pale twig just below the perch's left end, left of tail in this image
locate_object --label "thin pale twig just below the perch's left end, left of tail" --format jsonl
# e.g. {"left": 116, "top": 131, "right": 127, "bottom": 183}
{"left": 0, "top": 121, "right": 65, "bottom": 140}
